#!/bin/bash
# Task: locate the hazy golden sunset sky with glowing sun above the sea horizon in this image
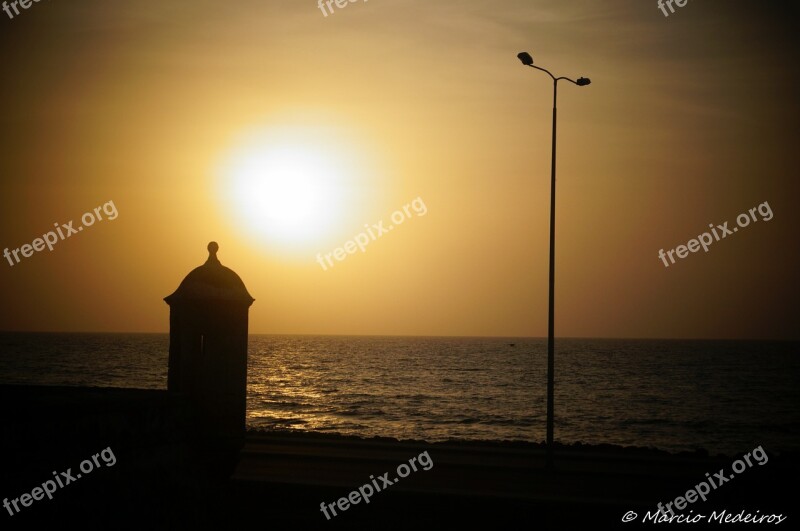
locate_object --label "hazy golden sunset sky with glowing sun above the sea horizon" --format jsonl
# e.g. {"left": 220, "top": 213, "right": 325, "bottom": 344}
{"left": 0, "top": 0, "right": 800, "bottom": 339}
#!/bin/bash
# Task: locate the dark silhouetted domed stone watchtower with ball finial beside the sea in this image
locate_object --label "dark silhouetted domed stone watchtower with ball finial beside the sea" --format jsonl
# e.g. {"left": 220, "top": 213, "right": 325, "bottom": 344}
{"left": 164, "top": 242, "right": 250, "bottom": 439}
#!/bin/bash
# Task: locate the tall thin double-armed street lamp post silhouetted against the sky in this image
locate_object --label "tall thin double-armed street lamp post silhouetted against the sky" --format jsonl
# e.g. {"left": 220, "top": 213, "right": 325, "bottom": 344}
{"left": 517, "top": 52, "right": 591, "bottom": 469}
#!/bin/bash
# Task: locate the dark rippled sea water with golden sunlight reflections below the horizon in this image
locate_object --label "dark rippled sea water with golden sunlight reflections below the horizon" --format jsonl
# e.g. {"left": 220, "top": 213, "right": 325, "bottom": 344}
{"left": 0, "top": 333, "right": 800, "bottom": 453}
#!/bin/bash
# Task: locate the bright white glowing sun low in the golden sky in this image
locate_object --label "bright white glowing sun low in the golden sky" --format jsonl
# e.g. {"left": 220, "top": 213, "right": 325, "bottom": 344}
{"left": 220, "top": 127, "right": 366, "bottom": 251}
